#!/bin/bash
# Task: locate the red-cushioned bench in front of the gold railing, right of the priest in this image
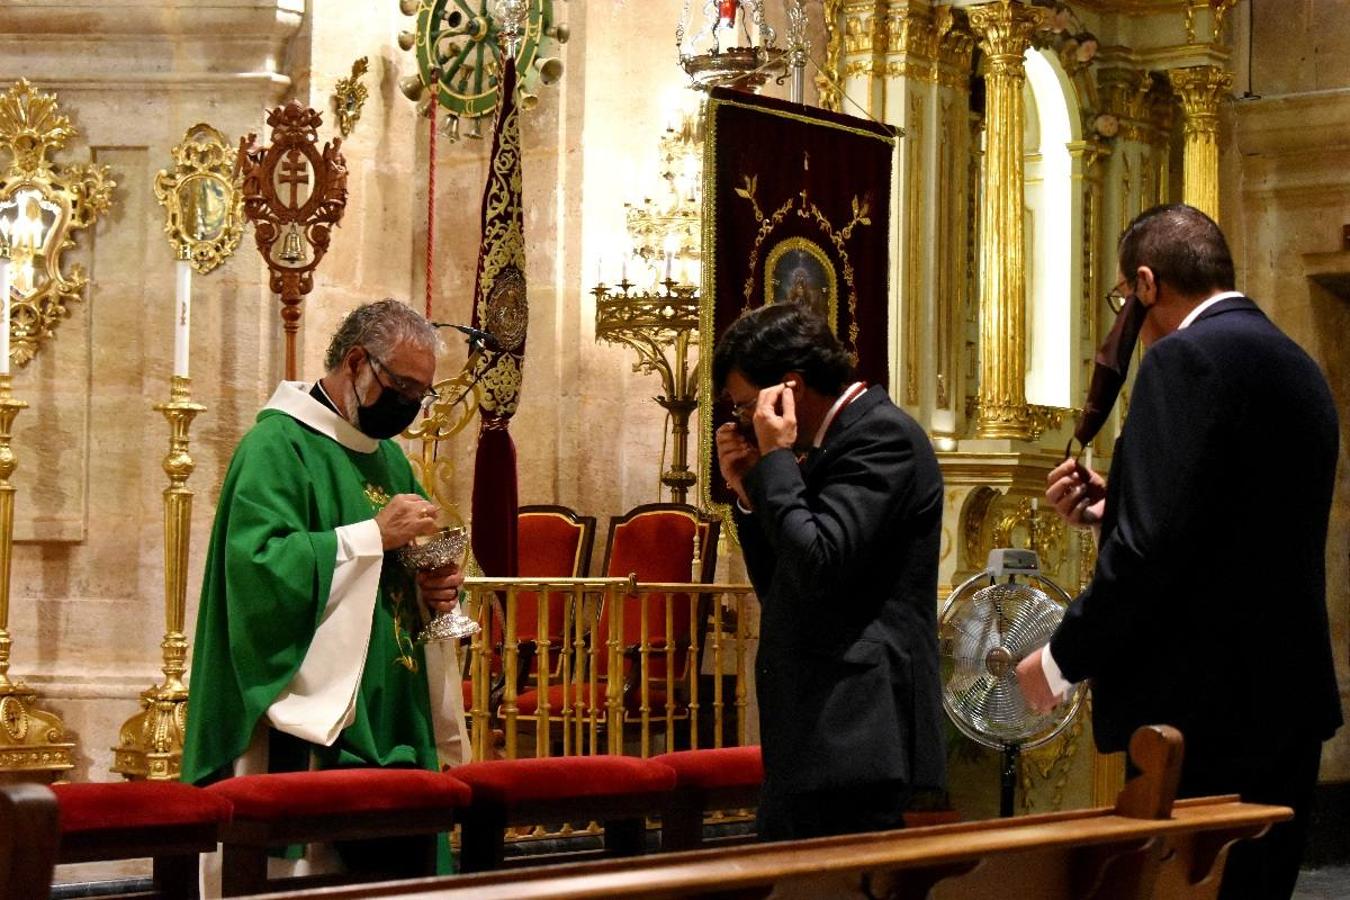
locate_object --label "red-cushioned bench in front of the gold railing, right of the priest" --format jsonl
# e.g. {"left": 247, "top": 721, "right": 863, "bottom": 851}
{"left": 451, "top": 756, "right": 675, "bottom": 872}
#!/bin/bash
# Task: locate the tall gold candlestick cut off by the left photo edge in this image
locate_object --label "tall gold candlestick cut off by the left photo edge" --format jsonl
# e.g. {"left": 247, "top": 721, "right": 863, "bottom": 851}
{"left": 0, "top": 364, "right": 76, "bottom": 781}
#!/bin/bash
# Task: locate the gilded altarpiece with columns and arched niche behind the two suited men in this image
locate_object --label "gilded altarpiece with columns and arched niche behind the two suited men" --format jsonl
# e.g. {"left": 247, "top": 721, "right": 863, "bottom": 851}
{"left": 819, "top": 0, "right": 1233, "bottom": 815}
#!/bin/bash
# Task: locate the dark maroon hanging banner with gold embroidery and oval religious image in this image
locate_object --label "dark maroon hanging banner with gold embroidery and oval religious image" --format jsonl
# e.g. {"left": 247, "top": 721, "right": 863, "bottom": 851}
{"left": 698, "top": 88, "right": 899, "bottom": 528}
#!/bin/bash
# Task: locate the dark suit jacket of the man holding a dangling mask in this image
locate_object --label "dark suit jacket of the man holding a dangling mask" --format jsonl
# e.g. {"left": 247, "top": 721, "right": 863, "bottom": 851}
{"left": 1050, "top": 297, "right": 1341, "bottom": 762}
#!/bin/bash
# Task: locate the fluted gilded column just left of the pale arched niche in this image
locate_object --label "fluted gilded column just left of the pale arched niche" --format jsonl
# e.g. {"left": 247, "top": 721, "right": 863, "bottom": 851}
{"left": 969, "top": 0, "right": 1042, "bottom": 440}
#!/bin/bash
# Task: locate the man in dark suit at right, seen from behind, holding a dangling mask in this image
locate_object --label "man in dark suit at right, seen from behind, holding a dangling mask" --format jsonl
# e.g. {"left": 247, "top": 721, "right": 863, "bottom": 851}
{"left": 1018, "top": 205, "right": 1342, "bottom": 900}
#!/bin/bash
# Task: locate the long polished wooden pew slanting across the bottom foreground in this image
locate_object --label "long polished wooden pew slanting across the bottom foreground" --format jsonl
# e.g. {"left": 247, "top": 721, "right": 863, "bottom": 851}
{"left": 260, "top": 726, "right": 1292, "bottom": 900}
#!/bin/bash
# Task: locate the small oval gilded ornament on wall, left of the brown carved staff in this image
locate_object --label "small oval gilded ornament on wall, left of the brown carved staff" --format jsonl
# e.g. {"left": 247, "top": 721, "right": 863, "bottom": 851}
{"left": 155, "top": 123, "right": 244, "bottom": 275}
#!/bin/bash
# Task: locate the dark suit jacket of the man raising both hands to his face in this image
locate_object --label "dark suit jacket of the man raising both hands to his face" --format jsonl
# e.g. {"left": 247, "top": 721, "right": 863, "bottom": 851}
{"left": 737, "top": 387, "right": 946, "bottom": 795}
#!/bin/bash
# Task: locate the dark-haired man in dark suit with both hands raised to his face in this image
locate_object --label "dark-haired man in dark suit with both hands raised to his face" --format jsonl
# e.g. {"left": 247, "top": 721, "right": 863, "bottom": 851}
{"left": 713, "top": 302, "right": 946, "bottom": 841}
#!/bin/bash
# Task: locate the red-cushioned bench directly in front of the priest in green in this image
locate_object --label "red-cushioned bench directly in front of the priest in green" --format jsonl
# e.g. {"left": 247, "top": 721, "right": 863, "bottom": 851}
{"left": 205, "top": 769, "right": 470, "bottom": 897}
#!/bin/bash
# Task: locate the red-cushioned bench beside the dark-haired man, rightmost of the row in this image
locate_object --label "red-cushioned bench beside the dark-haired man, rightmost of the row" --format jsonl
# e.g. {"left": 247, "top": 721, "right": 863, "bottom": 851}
{"left": 652, "top": 746, "right": 764, "bottom": 850}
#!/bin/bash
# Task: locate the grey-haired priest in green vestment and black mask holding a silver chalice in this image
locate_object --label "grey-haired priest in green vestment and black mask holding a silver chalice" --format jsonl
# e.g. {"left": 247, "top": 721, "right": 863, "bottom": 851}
{"left": 182, "top": 300, "right": 468, "bottom": 784}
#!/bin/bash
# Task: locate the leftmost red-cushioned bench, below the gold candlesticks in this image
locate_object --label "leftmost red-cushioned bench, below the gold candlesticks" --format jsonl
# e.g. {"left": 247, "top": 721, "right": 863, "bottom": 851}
{"left": 51, "top": 781, "right": 232, "bottom": 897}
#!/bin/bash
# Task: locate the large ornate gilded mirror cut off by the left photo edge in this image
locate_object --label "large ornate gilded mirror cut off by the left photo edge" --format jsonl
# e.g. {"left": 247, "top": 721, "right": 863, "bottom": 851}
{"left": 0, "top": 80, "right": 116, "bottom": 366}
